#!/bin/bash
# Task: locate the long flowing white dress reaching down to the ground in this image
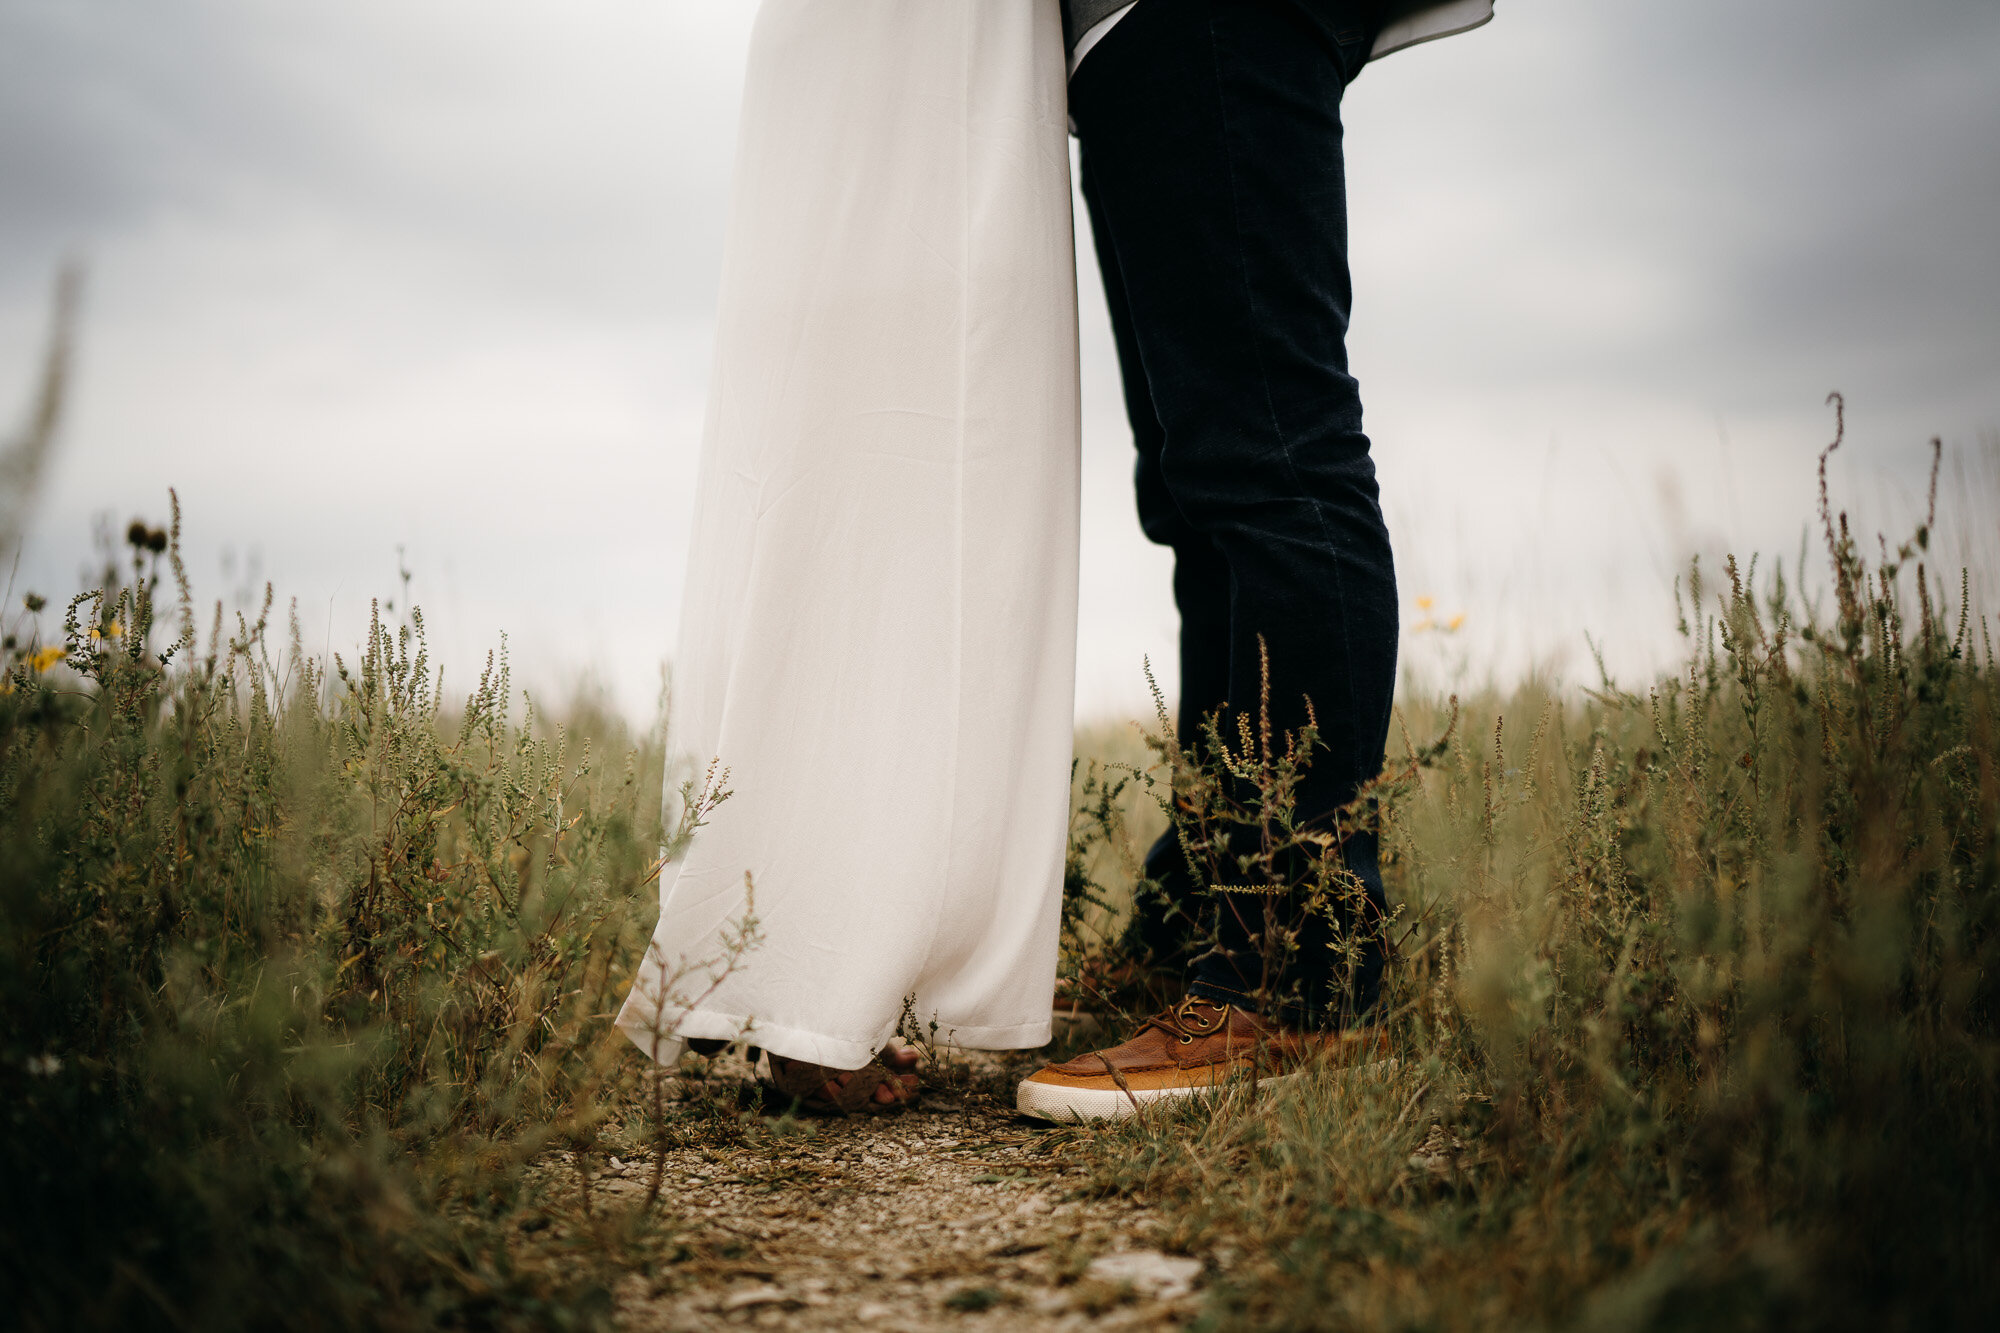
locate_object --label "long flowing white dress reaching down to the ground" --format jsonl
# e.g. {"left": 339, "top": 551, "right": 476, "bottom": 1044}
{"left": 618, "top": 0, "right": 1078, "bottom": 1069}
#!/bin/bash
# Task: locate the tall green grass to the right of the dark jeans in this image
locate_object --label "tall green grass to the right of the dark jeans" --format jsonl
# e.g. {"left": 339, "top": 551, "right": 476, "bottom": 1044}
{"left": 1052, "top": 464, "right": 2000, "bottom": 1329}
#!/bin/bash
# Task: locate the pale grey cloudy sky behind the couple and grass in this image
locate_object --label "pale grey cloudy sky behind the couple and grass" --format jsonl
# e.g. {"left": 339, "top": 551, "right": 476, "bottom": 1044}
{"left": 0, "top": 0, "right": 2000, "bottom": 713}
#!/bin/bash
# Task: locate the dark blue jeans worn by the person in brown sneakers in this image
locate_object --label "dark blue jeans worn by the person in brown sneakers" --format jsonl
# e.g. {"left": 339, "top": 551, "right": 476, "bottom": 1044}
{"left": 1070, "top": 0, "right": 1398, "bottom": 1023}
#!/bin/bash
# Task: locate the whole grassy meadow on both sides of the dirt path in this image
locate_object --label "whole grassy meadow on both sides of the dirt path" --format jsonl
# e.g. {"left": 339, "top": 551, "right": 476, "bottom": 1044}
{"left": 0, "top": 452, "right": 2000, "bottom": 1329}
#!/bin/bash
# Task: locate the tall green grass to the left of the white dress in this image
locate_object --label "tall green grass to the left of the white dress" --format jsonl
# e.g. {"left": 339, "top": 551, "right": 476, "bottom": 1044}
{"left": 0, "top": 496, "right": 670, "bottom": 1329}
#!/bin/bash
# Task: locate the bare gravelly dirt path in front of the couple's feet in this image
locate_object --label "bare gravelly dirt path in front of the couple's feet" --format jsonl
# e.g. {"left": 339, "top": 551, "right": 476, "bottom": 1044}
{"left": 572, "top": 1057, "right": 1206, "bottom": 1331}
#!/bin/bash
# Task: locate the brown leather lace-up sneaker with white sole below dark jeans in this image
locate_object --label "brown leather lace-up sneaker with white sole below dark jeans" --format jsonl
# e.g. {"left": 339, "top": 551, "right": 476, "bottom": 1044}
{"left": 1014, "top": 995, "right": 1388, "bottom": 1123}
